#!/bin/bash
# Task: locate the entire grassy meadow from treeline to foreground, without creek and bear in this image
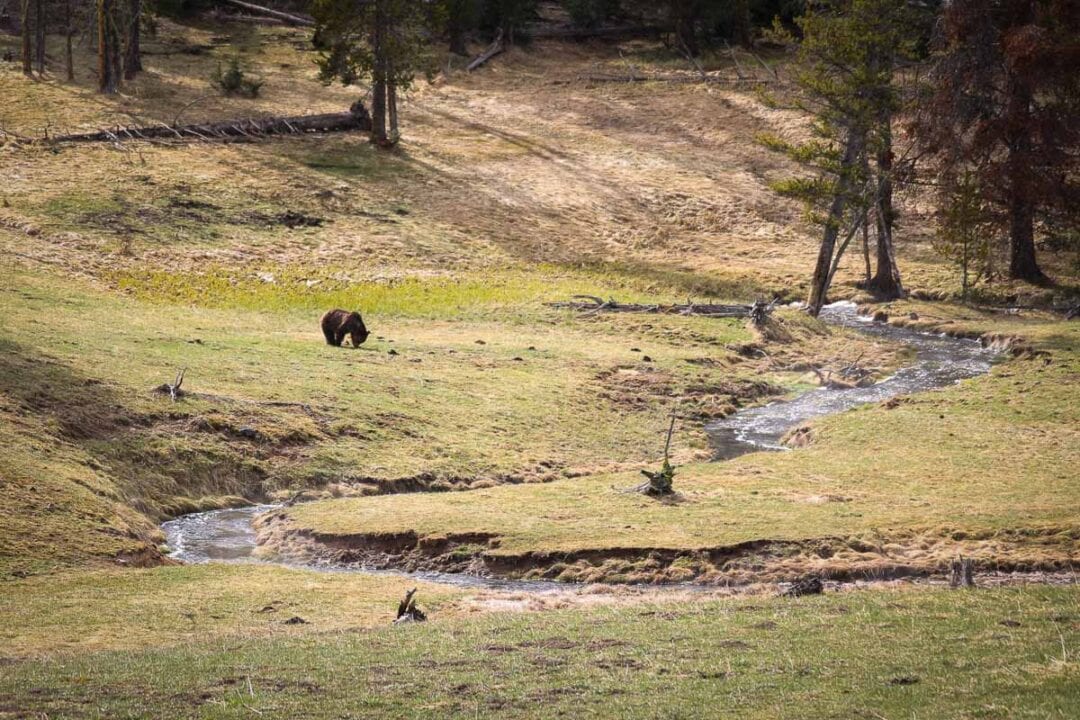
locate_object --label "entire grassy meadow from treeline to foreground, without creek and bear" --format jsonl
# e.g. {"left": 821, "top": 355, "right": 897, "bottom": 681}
{"left": 0, "top": 12, "right": 1080, "bottom": 720}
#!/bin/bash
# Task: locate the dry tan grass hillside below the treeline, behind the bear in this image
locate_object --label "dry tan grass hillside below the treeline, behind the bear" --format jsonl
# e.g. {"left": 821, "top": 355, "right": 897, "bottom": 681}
{"left": 0, "top": 23, "right": 963, "bottom": 294}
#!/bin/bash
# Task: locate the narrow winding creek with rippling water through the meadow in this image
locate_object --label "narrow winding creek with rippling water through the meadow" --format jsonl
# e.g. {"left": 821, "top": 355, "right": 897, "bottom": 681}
{"left": 162, "top": 302, "right": 996, "bottom": 592}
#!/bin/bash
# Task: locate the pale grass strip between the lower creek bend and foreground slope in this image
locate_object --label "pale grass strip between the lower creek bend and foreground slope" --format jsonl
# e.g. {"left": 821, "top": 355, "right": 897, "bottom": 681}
{"left": 0, "top": 563, "right": 462, "bottom": 662}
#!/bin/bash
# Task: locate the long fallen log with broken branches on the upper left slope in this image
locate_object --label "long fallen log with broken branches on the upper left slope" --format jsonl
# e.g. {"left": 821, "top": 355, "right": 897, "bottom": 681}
{"left": 39, "top": 103, "right": 372, "bottom": 142}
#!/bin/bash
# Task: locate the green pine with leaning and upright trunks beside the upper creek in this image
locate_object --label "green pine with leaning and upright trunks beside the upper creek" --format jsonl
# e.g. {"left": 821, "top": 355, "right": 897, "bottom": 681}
{"left": 761, "top": 0, "right": 916, "bottom": 315}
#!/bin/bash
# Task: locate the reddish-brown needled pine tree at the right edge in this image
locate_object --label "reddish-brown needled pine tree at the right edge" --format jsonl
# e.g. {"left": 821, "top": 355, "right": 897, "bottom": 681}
{"left": 914, "top": 0, "right": 1080, "bottom": 282}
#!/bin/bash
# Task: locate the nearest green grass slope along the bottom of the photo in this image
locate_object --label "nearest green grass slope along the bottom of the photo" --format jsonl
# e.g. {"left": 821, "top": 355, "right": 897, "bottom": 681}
{"left": 0, "top": 586, "right": 1080, "bottom": 720}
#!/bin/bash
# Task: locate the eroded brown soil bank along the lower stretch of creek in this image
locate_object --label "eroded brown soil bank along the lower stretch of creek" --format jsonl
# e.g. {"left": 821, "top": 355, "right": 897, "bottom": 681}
{"left": 255, "top": 511, "right": 1077, "bottom": 585}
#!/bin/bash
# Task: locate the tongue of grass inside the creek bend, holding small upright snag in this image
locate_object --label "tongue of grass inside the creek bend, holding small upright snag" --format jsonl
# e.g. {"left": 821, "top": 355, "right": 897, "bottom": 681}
{"left": 278, "top": 313, "right": 1080, "bottom": 580}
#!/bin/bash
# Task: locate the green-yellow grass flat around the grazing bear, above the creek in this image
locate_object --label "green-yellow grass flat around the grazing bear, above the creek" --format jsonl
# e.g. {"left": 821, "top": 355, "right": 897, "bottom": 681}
{"left": 0, "top": 267, "right": 895, "bottom": 573}
